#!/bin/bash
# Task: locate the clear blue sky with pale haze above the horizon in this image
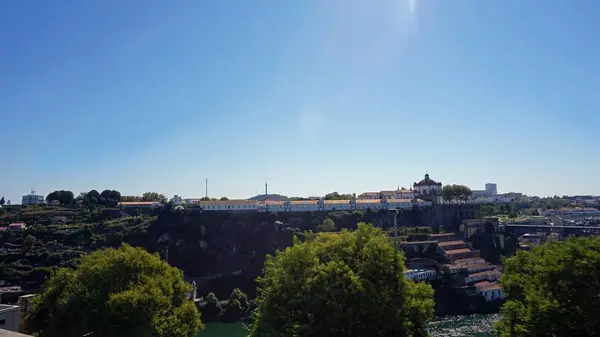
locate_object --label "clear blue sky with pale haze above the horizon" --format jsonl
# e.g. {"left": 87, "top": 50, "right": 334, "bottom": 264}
{"left": 0, "top": 0, "right": 600, "bottom": 203}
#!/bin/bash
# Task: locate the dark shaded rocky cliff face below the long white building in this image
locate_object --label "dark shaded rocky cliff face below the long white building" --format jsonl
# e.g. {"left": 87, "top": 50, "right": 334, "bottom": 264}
{"left": 146, "top": 205, "right": 476, "bottom": 277}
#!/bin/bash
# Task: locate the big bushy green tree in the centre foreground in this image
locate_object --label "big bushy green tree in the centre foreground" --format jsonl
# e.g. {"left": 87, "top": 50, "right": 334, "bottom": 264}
{"left": 249, "top": 224, "right": 434, "bottom": 337}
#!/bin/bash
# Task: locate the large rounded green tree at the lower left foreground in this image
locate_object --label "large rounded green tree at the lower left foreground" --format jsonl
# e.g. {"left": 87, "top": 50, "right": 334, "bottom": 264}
{"left": 27, "top": 245, "right": 202, "bottom": 337}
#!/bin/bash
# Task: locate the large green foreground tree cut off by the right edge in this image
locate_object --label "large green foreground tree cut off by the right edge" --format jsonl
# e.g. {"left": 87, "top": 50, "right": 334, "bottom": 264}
{"left": 496, "top": 237, "right": 600, "bottom": 337}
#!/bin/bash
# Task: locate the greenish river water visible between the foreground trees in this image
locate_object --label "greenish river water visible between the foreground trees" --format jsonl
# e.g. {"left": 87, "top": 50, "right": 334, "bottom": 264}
{"left": 198, "top": 314, "right": 499, "bottom": 337}
